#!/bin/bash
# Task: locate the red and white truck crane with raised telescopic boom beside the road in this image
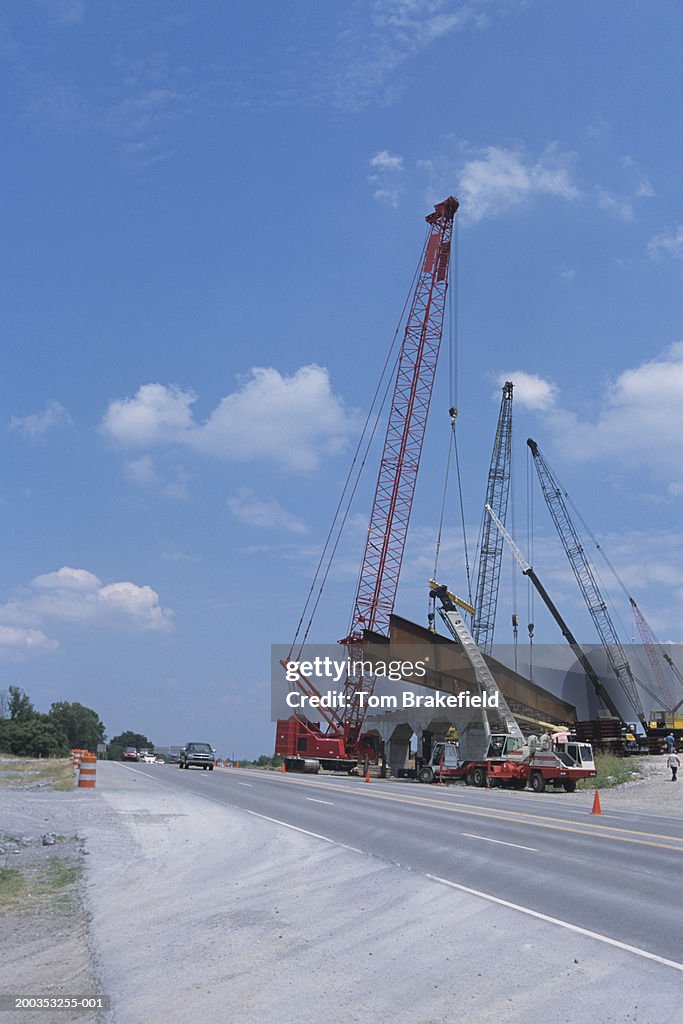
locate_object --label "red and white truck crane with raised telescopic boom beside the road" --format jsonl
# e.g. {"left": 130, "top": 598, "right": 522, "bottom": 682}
{"left": 416, "top": 580, "right": 596, "bottom": 793}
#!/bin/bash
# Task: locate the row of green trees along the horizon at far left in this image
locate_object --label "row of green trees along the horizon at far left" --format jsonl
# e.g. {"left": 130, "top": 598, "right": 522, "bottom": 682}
{"left": 0, "top": 686, "right": 154, "bottom": 760}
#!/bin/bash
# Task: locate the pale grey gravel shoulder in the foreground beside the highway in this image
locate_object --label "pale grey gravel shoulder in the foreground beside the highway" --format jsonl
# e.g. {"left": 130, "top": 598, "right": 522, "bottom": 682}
{"left": 0, "top": 763, "right": 680, "bottom": 1024}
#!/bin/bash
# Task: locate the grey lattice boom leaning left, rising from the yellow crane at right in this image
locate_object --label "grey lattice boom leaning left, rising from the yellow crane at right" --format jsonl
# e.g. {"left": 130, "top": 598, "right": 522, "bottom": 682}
{"left": 526, "top": 437, "right": 647, "bottom": 730}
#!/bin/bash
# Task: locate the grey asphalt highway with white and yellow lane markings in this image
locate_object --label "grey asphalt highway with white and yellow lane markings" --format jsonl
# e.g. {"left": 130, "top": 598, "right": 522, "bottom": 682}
{"left": 119, "top": 764, "right": 683, "bottom": 971}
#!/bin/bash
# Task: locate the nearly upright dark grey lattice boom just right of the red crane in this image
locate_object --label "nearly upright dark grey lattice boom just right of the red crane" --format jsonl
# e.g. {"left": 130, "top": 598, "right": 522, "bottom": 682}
{"left": 472, "top": 381, "right": 513, "bottom": 654}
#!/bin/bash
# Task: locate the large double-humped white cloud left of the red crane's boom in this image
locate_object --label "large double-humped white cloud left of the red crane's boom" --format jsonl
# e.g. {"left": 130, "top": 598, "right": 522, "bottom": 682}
{"left": 101, "top": 364, "right": 355, "bottom": 472}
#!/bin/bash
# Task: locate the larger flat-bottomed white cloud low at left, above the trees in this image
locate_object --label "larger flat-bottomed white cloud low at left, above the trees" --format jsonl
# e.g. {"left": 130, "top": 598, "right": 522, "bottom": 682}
{"left": 0, "top": 566, "right": 173, "bottom": 643}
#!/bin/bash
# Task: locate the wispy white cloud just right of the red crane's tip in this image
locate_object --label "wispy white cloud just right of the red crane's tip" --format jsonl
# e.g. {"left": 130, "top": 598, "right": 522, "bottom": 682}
{"left": 457, "top": 144, "right": 579, "bottom": 221}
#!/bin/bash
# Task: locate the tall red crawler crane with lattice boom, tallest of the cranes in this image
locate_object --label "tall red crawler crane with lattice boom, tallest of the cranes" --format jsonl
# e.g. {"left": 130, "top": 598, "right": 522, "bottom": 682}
{"left": 275, "top": 197, "right": 459, "bottom": 771}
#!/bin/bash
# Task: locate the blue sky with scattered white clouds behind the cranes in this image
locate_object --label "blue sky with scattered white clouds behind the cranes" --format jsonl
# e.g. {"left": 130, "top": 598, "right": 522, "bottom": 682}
{"left": 0, "top": 0, "right": 683, "bottom": 757}
